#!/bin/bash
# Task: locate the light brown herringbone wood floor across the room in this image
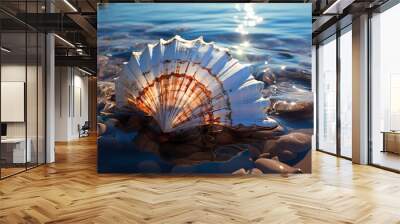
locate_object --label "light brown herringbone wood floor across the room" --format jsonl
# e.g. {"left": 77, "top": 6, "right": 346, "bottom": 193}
{"left": 0, "top": 138, "right": 400, "bottom": 224}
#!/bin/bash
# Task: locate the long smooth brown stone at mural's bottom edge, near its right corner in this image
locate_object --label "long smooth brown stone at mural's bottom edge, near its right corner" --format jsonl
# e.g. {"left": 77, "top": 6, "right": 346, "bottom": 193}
{"left": 255, "top": 158, "right": 302, "bottom": 173}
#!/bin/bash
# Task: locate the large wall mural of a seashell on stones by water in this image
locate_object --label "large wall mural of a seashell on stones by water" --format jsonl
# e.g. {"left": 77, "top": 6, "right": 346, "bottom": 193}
{"left": 97, "top": 3, "right": 313, "bottom": 174}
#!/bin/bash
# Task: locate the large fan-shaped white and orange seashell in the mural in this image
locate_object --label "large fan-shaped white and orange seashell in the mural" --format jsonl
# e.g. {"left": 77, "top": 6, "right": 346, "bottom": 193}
{"left": 115, "top": 36, "right": 277, "bottom": 133}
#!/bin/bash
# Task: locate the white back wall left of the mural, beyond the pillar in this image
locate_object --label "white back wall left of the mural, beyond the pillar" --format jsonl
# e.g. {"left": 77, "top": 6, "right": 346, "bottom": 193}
{"left": 55, "top": 67, "right": 88, "bottom": 141}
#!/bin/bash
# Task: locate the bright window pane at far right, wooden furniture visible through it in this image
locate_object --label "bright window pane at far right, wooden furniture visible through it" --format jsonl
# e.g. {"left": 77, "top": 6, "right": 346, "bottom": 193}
{"left": 371, "top": 4, "right": 400, "bottom": 170}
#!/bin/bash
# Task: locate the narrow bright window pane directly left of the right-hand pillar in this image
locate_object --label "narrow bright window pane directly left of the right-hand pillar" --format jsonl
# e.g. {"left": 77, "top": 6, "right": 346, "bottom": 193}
{"left": 340, "top": 30, "right": 353, "bottom": 158}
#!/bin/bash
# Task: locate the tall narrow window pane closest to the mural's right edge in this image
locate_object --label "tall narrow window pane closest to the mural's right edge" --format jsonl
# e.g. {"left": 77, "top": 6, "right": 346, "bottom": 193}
{"left": 318, "top": 39, "right": 336, "bottom": 153}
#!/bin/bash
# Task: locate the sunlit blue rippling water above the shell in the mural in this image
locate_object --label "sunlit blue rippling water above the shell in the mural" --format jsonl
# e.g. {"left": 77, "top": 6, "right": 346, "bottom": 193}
{"left": 97, "top": 3, "right": 311, "bottom": 83}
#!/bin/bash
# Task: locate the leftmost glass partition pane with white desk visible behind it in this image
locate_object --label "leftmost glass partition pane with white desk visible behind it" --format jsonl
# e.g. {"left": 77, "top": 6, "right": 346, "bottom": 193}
{"left": 1, "top": 32, "right": 27, "bottom": 177}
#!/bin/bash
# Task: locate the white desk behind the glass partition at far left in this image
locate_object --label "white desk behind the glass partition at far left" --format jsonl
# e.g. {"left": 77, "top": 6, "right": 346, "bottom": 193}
{"left": 1, "top": 138, "right": 32, "bottom": 163}
